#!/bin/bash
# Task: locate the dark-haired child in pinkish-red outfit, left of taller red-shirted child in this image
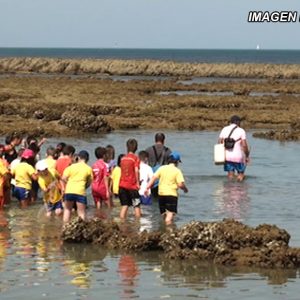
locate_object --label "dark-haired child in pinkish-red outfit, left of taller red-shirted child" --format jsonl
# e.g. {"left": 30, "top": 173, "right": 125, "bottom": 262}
{"left": 92, "top": 147, "right": 111, "bottom": 209}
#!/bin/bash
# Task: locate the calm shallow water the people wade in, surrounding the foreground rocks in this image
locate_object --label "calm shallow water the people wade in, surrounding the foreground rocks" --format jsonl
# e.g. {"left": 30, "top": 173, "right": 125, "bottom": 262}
{"left": 0, "top": 131, "right": 300, "bottom": 300}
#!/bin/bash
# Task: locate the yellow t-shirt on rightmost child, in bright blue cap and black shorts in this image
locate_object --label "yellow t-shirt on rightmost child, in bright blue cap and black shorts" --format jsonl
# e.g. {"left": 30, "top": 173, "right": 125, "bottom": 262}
{"left": 154, "top": 164, "right": 184, "bottom": 197}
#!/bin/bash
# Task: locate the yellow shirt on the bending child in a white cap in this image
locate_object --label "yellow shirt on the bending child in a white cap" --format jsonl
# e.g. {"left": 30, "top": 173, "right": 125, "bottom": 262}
{"left": 38, "top": 169, "right": 62, "bottom": 204}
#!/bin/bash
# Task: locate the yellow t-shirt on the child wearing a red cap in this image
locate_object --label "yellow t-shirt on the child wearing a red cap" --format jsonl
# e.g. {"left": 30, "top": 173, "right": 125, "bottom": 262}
{"left": 11, "top": 162, "right": 35, "bottom": 190}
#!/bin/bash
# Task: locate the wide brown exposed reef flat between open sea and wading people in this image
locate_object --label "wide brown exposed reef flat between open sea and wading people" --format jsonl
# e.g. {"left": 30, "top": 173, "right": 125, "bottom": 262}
{"left": 0, "top": 58, "right": 300, "bottom": 140}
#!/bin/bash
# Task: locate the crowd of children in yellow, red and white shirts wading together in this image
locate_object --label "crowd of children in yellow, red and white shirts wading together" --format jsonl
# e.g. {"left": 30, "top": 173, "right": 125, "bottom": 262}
{"left": 0, "top": 134, "right": 188, "bottom": 224}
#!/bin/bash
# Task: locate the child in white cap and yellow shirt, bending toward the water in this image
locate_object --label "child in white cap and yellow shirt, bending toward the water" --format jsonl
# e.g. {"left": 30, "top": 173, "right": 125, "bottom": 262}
{"left": 36, "top": 160, "right": 63, "bottom": 217}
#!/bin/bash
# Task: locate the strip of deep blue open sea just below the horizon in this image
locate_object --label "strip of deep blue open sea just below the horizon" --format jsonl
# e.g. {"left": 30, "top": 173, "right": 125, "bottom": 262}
{"left": 0, "top": 48, "right": 300, "bottom": 64}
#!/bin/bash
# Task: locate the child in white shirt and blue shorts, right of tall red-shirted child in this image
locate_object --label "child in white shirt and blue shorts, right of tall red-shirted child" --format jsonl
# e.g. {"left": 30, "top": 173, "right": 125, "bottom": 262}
{"left": 139, "top": 151, "right": 153, "bottom": 205}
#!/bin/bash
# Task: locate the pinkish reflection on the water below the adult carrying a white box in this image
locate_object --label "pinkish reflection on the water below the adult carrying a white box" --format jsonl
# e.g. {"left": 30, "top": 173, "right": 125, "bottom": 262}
{"left": 213, "top": 180, "right": 251, "bottom": 221}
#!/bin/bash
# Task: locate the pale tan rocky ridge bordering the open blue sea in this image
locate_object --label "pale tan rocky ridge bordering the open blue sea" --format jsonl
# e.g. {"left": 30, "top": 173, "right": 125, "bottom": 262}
{"left": 0, "top": 57, "right": 300, "bottom": 79}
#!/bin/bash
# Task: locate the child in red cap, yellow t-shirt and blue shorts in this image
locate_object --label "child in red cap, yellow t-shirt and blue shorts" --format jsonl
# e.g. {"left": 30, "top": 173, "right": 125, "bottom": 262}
{"left": 11, "top": 149, "right": 37, "bottom": 208}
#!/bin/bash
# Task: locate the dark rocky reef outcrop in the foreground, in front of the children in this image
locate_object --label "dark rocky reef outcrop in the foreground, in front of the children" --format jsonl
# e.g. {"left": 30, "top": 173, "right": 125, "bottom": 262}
{"left": 62, "top": 218, "right": 300, "bottom": 268}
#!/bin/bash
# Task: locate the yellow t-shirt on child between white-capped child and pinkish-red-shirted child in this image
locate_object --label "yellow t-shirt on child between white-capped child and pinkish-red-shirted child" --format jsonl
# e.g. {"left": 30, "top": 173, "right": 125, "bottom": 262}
{"left": 63, "top": 162, "right": 93, "bottom": 196}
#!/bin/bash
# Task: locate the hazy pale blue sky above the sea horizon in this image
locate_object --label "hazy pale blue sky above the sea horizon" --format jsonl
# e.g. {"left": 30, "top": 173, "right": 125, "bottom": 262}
{"left": 0, "top": 0, "right": 300, "bottom": 49}
